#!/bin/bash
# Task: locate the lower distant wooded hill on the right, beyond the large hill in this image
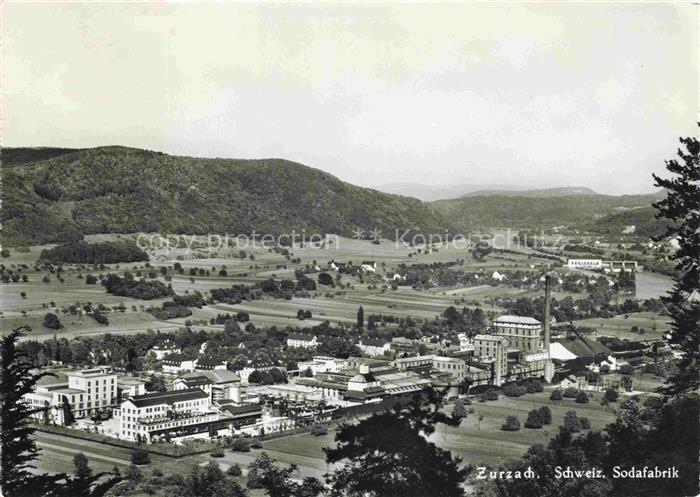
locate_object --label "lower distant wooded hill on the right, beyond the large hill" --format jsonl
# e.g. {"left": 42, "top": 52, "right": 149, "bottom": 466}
{"left": 430, "top": 192, "right": 663, "bottom": 231}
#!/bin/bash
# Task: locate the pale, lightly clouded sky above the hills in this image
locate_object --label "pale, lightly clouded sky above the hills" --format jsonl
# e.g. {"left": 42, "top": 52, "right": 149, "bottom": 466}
{"left": 1, "top": 2, "right": 699, "bottom": 194}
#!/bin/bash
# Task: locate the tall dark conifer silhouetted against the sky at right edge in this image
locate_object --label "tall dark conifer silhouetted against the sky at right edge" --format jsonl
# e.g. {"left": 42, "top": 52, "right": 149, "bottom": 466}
{"left": 654, "top": 133, "right": 700, "bottom": 394}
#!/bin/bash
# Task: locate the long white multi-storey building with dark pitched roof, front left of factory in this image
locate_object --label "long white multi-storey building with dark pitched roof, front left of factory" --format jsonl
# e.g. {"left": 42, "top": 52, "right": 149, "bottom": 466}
{"left": 114, "top": 388, "right": 219, "bottom": 442}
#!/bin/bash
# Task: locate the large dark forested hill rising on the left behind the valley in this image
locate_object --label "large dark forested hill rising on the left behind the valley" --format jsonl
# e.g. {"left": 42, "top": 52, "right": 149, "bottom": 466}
{"left": 0, "top": 147, "right": 446, "bottom": 245}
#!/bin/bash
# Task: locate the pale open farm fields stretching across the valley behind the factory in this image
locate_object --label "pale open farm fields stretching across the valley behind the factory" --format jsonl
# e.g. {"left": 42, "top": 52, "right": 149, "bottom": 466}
{"left": 0, "top": 232, "right": 668, "bottom": 340}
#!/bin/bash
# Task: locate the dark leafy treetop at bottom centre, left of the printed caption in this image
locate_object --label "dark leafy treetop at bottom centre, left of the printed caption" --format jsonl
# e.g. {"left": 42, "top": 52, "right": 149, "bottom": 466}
{"left": 324, "top": 389, "right": 469, "bottom": 497}
